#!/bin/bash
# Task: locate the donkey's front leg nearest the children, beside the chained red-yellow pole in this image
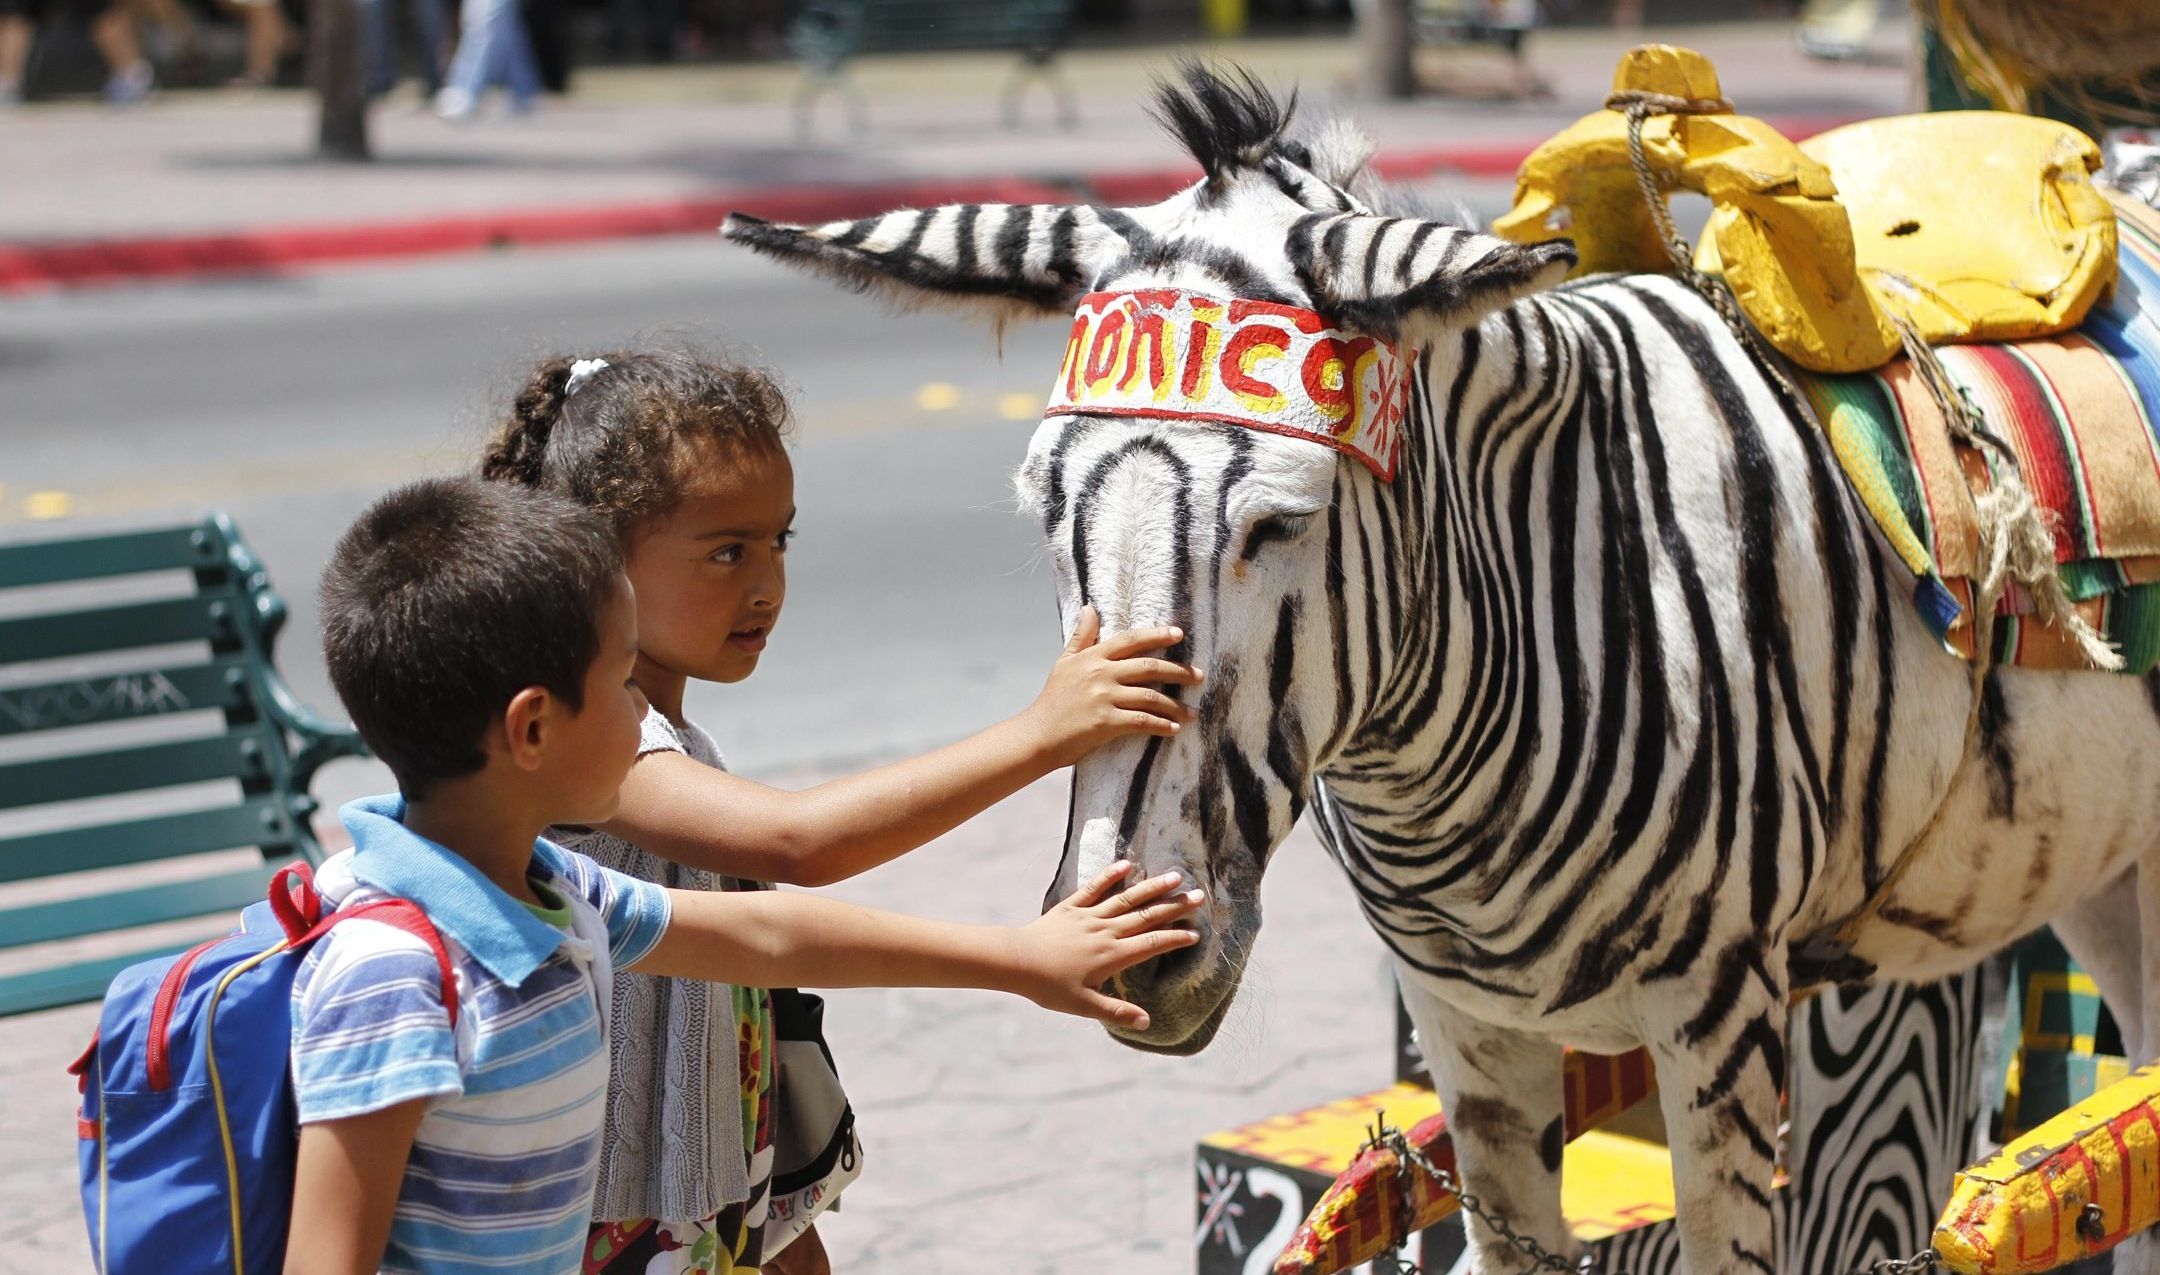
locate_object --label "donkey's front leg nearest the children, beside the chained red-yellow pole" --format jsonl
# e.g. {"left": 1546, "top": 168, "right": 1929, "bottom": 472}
{"left": 1402, "top": 970, "right": 1577, "bottom": 1275}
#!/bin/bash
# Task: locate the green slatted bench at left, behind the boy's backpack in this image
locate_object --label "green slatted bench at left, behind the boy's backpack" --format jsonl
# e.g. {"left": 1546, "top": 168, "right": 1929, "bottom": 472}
{"left": 0, "top": 514, "right": 365, "bottom": 1016}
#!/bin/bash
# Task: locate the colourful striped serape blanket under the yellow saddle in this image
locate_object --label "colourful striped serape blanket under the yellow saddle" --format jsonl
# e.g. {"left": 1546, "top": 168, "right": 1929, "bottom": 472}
{"left": 1799, "top": 194, "right": 2160, "bottom": 674}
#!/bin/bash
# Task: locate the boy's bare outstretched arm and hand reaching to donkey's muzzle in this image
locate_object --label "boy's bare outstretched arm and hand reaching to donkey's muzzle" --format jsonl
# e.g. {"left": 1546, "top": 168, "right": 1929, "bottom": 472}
{"left": 631, "top": 862, "right": 1201, "bottom": 1031}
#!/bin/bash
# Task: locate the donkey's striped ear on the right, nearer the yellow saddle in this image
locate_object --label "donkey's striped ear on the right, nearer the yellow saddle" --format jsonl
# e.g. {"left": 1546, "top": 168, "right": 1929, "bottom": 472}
{"left": 1290, "top": 214, "right": 1575, "bottom": 339}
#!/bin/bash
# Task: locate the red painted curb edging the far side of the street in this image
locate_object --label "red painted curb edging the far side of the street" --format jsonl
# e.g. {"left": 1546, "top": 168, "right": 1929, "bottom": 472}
{"left": 0, "top": 119, "right": 1847, "bottom": 292}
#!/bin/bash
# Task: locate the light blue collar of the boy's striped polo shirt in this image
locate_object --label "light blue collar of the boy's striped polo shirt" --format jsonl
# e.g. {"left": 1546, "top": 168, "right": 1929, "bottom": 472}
{"left": 337, "top": 793, "right": 568, "bottom": 985}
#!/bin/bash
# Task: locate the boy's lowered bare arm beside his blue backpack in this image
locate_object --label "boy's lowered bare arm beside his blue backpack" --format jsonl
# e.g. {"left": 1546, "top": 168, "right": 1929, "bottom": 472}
{"left": 285, "top": 1098, "right": 428, "bottom": 1275}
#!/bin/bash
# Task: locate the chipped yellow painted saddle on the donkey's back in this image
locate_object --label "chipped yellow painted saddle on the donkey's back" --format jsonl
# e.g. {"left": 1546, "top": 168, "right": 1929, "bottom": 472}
{"left": 1493, "top": 45, "right": 2115, "bottom": 372}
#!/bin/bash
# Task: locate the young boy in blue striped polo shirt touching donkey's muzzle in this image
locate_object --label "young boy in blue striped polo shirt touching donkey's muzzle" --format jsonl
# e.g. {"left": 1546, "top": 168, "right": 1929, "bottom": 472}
{"left": 285, "top": 480, "right": 1199, "bottom": 1275}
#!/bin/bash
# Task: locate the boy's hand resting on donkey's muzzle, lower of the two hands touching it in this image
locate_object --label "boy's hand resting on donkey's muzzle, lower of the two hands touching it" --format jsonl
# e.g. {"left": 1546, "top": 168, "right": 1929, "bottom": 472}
{"left": 1015, "top": 860, "right": 1203, "bottom": 1031}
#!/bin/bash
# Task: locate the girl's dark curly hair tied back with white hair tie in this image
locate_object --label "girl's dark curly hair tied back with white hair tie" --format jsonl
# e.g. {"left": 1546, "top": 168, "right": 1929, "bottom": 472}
{"left": 480, "top": 350, "right": 788, "bottom": 534}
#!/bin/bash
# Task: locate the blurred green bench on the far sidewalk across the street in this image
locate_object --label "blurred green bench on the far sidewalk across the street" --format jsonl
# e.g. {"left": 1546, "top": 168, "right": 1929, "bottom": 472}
{"left": 788, "top": 0, "right": 1080, "bottom": 138}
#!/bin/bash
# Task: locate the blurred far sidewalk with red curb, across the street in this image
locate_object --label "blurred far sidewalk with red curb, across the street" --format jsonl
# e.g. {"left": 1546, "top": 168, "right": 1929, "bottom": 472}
{"left": 0, "top": 24, "right": 1907, "bottom": 285}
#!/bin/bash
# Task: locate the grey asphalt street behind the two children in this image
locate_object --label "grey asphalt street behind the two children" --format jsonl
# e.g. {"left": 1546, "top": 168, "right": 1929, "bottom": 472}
{"left": 0, "top": 238, "right": 1080, "bottom": 797}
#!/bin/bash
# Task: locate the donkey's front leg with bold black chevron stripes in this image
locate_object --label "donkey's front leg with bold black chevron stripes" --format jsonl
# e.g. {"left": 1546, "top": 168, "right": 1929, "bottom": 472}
{"left": 1642, "top": 938, "right": 1779, "bottom": 1275}
